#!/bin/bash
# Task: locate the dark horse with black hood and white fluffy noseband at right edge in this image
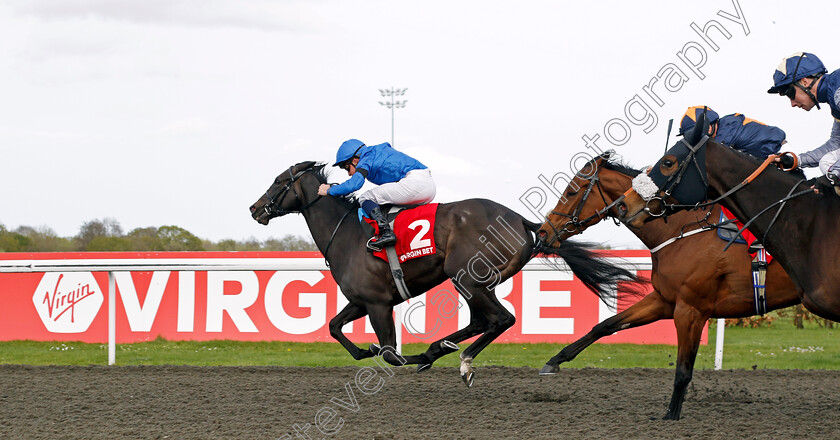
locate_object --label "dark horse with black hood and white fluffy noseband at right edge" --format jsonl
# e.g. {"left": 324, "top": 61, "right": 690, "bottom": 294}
{"left": 619, "top": 117, "right": 840, "bottom": 321}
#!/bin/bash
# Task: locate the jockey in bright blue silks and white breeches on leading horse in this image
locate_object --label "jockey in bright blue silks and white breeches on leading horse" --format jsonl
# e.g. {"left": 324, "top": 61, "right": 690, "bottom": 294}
{"left": 318, "top": 139, "right": 436, "bottom": 250}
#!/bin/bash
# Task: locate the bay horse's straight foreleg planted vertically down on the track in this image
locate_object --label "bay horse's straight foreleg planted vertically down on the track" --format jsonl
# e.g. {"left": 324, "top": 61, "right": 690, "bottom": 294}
{"left": 662, "top": 303, "right": 709, "bottom": 420}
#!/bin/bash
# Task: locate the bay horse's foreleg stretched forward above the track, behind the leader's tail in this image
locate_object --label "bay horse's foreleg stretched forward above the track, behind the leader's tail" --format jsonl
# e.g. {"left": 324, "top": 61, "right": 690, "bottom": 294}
{"left": 540, "top": 290, "right": 674, "bottom": 376}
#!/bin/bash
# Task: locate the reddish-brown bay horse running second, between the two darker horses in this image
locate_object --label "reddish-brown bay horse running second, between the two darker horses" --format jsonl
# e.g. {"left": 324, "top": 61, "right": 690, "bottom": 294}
{"left": 538, "top": 152, "right": 799, "bottom": 420}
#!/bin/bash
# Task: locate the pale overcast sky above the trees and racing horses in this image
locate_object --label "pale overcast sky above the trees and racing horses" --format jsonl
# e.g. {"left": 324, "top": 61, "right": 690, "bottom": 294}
{"left": 0, "top": 0, "right": 840, "bottom": 248}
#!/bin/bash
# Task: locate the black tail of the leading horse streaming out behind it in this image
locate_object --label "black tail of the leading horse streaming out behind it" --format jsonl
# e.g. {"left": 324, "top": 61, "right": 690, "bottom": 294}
{"left": 534, "top": 240, "right": 649, "bottom": 306}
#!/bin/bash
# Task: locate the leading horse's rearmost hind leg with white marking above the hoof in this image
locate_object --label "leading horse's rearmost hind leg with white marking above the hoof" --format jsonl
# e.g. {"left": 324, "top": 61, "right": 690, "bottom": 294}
{"left": 461, "top": 285, "right": 516, "bottom": 387}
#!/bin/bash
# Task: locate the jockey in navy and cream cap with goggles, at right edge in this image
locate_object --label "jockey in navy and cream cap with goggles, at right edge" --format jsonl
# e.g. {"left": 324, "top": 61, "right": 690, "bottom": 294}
{"left": 767, "top": 52, "right": 840, "bottom": 194}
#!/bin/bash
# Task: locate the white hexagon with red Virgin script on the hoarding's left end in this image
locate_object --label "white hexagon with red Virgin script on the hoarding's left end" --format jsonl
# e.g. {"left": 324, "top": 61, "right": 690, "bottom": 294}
{"left": 32, "top": 272, "right": 105, "bottom": 333}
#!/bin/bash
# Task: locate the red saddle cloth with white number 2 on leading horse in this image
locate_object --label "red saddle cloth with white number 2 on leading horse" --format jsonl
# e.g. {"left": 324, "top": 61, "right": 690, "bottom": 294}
{"left": 359, "top": 203, "right": 438, "bottom": 263}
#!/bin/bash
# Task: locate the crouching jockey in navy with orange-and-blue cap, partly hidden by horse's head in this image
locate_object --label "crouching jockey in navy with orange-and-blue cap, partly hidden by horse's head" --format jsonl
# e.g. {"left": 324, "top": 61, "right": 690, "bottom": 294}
{"left": 678, "top": 105, "right": 785, "bottom": 159}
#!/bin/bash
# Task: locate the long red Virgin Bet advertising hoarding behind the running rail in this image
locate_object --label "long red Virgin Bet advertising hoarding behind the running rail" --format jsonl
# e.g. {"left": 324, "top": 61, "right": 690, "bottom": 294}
{"left": 0, "top": 251, "right": 707, "bottom": 344}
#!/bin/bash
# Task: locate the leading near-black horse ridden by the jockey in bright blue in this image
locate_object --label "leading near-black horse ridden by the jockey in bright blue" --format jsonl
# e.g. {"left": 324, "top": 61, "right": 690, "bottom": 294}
{"left": 250, "top": 162, "right": 635, "bottom": 386}
